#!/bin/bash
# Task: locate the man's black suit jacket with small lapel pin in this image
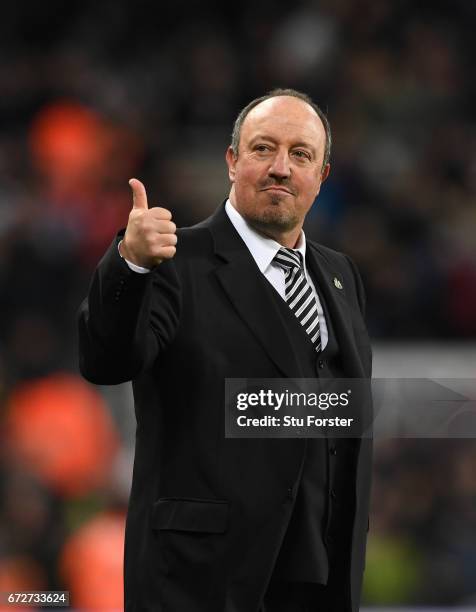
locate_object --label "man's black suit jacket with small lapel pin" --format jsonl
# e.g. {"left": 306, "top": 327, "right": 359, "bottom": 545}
{"left": 79, "top": 206, "right": 371, "bottom": 612}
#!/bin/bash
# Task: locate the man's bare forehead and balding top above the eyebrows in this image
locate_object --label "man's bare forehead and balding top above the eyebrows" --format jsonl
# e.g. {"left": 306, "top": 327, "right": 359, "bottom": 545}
{"left": 241, "top": 96, "right": 326, "bottom": 148}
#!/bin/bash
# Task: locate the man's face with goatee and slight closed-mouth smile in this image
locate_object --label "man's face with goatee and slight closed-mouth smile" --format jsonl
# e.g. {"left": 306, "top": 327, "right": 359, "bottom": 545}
{"left": 226, "top": 96, "right": 329, "bottom": 240}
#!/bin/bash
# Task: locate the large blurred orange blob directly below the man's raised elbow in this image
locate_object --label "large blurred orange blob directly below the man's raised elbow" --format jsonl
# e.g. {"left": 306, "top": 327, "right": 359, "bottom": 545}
{"left": 6, "top": 374, "right": 119, "bottom": 496}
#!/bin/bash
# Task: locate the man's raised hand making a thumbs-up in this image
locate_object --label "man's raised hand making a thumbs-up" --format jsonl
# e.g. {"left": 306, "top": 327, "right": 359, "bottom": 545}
{"left": 120, "top": 179, "right": 177, "bottom": 268}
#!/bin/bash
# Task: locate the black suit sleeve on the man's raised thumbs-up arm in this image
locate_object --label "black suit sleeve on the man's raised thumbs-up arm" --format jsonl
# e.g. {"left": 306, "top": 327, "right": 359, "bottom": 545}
{"left": 78, "top": 236, "right": 181, "bottom": 385}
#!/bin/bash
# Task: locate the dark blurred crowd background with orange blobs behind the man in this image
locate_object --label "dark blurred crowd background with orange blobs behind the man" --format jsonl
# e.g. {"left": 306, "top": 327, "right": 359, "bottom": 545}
{"left": 0, "top": 0, "right": 476, "bottom": 610}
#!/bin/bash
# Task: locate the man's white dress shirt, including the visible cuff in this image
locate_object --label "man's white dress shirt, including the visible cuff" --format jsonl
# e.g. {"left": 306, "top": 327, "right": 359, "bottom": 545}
{"left": 118, "top": 200, "right": 329, "bottom": 350}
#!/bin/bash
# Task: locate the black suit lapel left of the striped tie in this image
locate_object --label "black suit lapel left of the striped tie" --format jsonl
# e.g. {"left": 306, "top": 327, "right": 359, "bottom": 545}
{"left": 203, "top": 206, "right": 302, "bottom": 378}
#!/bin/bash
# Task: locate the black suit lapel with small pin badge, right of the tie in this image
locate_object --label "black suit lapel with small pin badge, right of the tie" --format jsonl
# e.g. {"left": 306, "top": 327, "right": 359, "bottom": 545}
{"left": 306, "top": 242, "right": 364, "bottom": 378}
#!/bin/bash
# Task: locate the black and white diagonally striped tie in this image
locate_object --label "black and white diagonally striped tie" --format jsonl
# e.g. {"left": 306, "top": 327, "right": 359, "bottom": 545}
{"left": 274, "top": 247, "right": 321, "bottom": 352}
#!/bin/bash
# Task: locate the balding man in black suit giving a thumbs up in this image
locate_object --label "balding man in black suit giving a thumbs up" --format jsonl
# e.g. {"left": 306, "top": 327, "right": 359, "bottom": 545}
{"left": 79, "top": 90, "right": 371, "bottom": 612}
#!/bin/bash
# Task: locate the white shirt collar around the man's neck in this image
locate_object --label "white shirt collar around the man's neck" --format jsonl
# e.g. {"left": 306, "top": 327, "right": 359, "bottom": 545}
{"left": 225, "top": 200, "right": 306, "bottom": 273}
